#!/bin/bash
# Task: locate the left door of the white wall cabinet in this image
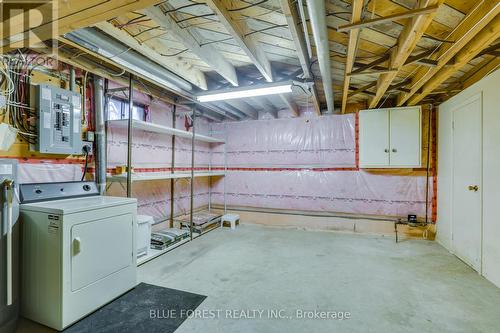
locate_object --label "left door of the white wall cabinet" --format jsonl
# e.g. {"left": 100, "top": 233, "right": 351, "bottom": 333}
{"left": 359, "top": 110, "right": 389, "bottom": 168}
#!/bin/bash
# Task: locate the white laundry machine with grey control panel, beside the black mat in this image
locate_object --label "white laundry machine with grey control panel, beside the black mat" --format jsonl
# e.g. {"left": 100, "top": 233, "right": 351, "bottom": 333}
{"left": 20, "top": 182, "right": 137, "bottom": 330}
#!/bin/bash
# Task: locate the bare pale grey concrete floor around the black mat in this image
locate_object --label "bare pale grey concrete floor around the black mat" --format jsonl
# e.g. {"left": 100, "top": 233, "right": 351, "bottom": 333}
{"left": 18, "top": 225, "right": 500, "bottom": 333}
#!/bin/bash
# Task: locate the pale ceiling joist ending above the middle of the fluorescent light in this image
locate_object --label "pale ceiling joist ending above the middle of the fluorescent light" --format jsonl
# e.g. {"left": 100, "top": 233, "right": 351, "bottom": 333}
{"left": 143, "top": 6, "right": 238, "bottom": 86}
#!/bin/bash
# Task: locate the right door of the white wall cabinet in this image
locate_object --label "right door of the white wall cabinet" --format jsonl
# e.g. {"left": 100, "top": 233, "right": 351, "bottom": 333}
{"left": 389, "top": 107, "right": 421, "bottom": 167}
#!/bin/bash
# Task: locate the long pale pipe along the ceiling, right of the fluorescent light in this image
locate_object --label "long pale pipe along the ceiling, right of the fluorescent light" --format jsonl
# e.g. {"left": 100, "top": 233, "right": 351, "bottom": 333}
{"left": 307, "top": 0, "right": 334, "bottom": 113}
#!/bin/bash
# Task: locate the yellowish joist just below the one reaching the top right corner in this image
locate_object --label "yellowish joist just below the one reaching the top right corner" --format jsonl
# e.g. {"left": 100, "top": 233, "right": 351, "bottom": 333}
{"left": 408, "top": 15, "right": 500, "bottom": 105}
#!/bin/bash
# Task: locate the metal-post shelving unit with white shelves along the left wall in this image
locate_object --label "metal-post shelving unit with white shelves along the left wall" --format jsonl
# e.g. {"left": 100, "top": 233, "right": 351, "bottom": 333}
{"left": 106, "top": 75, "right": 227, "bottom": 265}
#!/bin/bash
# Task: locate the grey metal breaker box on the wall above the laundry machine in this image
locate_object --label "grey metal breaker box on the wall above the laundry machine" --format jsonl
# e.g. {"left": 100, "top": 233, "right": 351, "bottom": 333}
{"left": 34, "top": 84, "right": 82, "bottom": 154}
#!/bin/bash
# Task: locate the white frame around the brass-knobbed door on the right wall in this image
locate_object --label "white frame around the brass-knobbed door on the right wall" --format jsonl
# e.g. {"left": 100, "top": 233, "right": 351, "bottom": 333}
{"left": 450, "top": 91, "right": 483, "bottom": 274}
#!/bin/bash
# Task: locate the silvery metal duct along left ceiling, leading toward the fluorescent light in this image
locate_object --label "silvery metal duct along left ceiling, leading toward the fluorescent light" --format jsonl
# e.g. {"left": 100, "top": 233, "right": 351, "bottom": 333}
{"left": 64, "top": 28, "right": 193, "bottom": 94}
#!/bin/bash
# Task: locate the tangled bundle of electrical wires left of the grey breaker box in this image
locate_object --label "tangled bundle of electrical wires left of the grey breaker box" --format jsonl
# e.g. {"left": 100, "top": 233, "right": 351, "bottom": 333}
{"left": 0, "top": 51, "right": 42, "bottom": 144}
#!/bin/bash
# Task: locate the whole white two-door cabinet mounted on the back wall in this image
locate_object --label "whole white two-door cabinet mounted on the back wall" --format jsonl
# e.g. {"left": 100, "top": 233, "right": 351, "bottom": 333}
{"left": 359, "top": 106, "right": 422, "bottom": 168}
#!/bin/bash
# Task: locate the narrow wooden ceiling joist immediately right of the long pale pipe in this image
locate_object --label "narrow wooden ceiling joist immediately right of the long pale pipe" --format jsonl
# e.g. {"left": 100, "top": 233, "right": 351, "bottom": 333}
{"left": 341, "top": 0, "right": 364, "bottom": 113}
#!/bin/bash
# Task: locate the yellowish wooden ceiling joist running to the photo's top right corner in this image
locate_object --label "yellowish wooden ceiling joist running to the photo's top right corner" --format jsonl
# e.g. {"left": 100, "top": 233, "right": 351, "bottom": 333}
{"left": 398, "top": 1, "right": 500, "bottom": 106}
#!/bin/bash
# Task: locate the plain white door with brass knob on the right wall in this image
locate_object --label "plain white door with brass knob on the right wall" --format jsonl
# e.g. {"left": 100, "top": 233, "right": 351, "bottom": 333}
{"left": 451, "top": 94, "right": 482, "bottom": 272}
